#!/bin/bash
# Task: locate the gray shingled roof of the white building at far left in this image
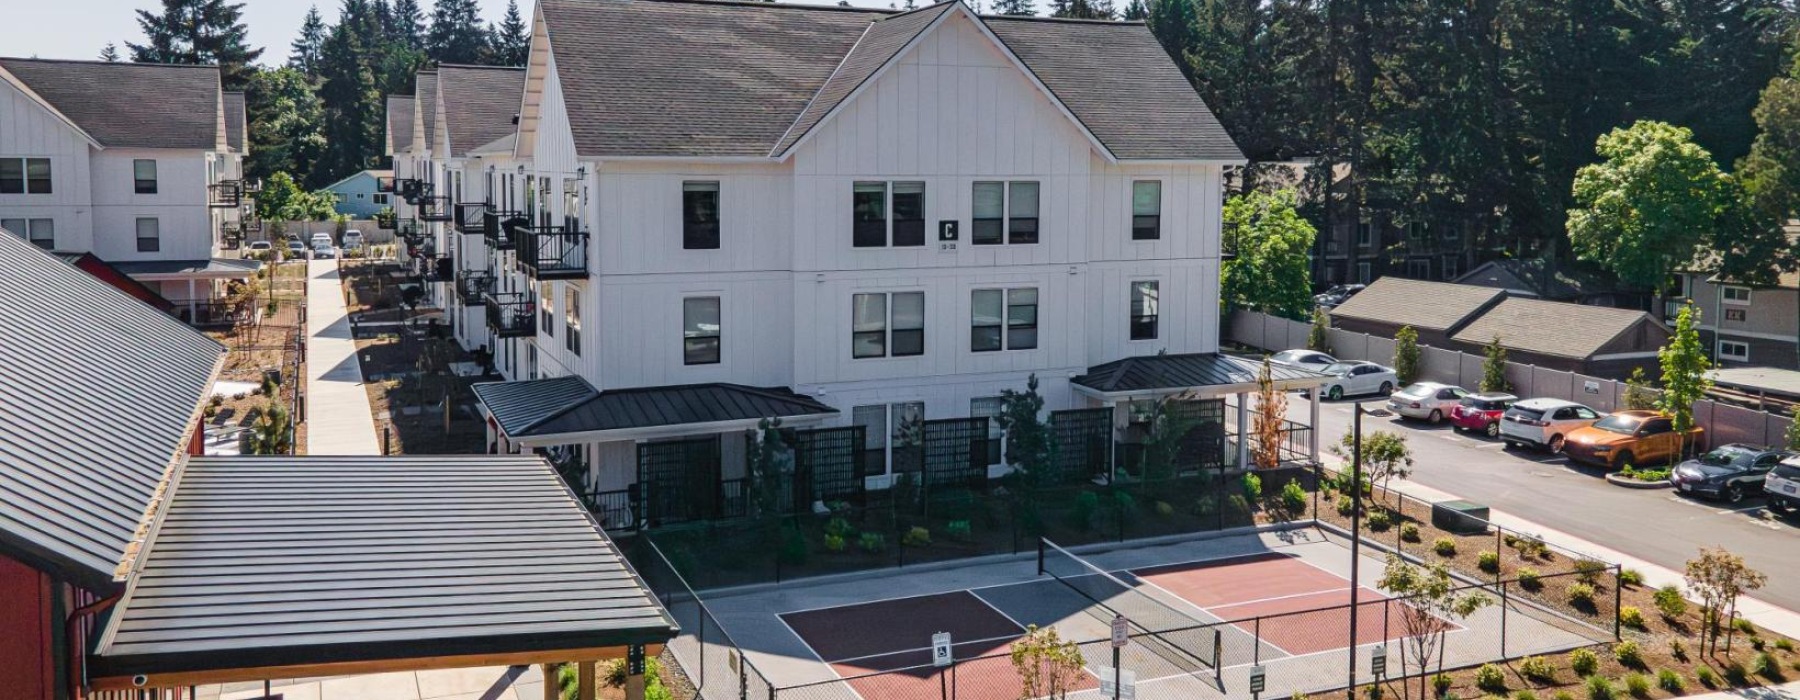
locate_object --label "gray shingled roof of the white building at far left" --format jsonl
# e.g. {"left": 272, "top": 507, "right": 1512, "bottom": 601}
{"left": 0, "top": 58, "right": 220, "bottom": 151}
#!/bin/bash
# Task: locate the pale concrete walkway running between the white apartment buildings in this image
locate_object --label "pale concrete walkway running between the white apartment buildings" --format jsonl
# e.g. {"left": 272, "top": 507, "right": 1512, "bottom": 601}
{"left": 306, "top": 259, "right": 382, "bottom": 455}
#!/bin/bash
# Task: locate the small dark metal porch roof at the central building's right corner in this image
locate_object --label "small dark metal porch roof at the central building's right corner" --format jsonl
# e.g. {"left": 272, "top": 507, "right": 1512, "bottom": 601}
{"left": 1069, "top": 353, "right": 1323, "bottom": 394}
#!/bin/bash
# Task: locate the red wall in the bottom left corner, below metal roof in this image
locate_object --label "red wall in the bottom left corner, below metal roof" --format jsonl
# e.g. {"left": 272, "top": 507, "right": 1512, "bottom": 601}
{"left": 0, "top": 556, "right": 56, "bottom": 700}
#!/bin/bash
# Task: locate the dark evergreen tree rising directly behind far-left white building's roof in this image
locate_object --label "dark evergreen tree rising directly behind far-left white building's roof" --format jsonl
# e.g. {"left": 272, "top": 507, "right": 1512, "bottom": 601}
{"left": 126, "top": 0, "right": 263, "bottom": 90}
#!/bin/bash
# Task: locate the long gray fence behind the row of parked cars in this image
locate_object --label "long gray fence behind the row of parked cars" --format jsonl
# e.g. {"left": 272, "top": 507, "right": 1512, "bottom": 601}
{"left": 1226, "top": 311, "right": 1789, "bottom": 444}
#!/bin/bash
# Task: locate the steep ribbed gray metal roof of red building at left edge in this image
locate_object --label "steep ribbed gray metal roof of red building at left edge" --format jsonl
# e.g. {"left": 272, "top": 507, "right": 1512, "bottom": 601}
{"left": 0, "top": 236, "right": 225, "bottom": 590}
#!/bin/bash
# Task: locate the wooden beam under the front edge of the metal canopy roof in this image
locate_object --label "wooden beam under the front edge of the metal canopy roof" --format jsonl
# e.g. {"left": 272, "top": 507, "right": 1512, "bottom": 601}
{"left": 88, "top": 644, "right": 662, "bottom": 691}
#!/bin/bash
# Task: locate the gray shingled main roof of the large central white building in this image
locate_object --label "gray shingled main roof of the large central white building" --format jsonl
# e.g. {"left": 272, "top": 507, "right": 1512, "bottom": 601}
{"left": 540, "top": 0, "right": 1242, "bottom": 160}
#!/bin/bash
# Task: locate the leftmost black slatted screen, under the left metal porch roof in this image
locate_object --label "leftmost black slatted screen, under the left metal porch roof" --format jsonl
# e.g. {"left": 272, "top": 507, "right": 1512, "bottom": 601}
{"left": 637, "top": 435, "right": 724, "bottom": 525}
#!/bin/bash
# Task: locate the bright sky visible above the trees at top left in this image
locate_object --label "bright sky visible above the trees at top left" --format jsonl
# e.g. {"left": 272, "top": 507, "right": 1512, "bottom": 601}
{"left": 0, "top": 0, "right": 887, "bottom": 65}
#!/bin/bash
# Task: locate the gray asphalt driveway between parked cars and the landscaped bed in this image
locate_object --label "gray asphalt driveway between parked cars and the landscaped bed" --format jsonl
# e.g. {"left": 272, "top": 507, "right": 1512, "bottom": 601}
{"left": 1288, "top": 396, "right": 1800, "bottom": 610}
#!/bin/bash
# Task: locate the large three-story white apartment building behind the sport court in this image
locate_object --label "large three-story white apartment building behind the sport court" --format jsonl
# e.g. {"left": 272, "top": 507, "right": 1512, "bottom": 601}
{"left": 396, "top": 0, "right": 1316, "bottom": 527}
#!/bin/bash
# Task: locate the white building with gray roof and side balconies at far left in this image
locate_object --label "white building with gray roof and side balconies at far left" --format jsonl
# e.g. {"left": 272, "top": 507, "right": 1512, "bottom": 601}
{"left": 0, "top": 58, "right": 254, "bottom": 324}
